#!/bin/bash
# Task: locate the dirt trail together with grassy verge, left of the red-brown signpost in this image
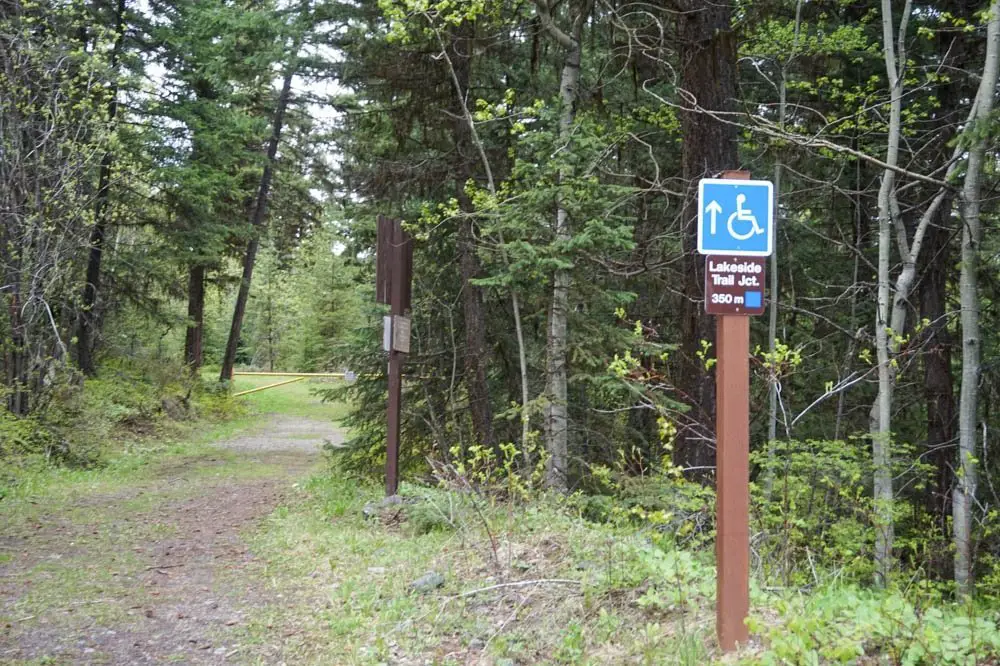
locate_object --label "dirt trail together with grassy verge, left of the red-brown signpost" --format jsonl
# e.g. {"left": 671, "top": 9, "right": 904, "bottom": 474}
{"left": 0, "top": 380, "right": 714, "bottom": 666}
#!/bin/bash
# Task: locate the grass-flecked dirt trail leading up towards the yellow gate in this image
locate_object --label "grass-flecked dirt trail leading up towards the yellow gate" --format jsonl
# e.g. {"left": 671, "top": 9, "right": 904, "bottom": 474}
{"left": 0, "top": 415, "right": 343, "bottom": 664}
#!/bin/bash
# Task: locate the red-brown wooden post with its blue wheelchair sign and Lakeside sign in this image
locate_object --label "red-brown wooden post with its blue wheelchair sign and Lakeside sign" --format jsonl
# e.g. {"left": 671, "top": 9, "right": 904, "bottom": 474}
{"left": 698, "top": 171, "right": 773, "bottom": 652}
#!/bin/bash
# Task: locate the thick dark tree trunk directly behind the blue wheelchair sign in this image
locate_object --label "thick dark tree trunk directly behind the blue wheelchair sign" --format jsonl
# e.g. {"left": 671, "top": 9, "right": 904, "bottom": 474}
{"left": 676, "top": 0, "right": 739, "bottom": 468}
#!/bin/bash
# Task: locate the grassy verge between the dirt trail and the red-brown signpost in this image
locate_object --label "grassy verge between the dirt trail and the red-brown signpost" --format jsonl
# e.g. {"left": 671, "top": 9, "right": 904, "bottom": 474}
{"left": 232, "top": 472, "right": 713, "bottom": 665}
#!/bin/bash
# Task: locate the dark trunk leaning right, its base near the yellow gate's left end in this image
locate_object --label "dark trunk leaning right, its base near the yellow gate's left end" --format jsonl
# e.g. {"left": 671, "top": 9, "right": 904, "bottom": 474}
{"left": 219, "top": 65, "right": 299, "bottom": 382}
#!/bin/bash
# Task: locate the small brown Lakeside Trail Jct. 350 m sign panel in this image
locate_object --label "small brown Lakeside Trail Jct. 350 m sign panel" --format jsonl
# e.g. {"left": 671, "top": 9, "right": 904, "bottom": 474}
{"left": 705, "top": 254, "right": 767, "bottom": 315}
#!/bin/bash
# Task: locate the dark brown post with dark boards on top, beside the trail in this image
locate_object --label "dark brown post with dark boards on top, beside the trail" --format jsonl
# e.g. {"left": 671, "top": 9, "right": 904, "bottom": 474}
{"left": 375, "top": 215, "right": 413, "bottom": 497}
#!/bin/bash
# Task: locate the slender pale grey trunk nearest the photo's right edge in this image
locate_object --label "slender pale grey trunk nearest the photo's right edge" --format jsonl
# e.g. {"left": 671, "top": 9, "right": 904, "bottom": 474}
{"left": 952, "top": 0, "right": 1000, "bottom": 596}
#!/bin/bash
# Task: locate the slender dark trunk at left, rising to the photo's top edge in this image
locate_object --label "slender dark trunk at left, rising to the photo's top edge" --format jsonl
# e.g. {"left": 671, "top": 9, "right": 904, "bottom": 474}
{"left": 76, "top": 0, "right": 126, "bottom": 377}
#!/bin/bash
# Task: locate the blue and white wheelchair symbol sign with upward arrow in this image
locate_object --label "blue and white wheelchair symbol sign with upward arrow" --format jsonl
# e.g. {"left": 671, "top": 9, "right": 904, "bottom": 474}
{"left": 698, "top": 178, "right": 774, "bottom": 257}
